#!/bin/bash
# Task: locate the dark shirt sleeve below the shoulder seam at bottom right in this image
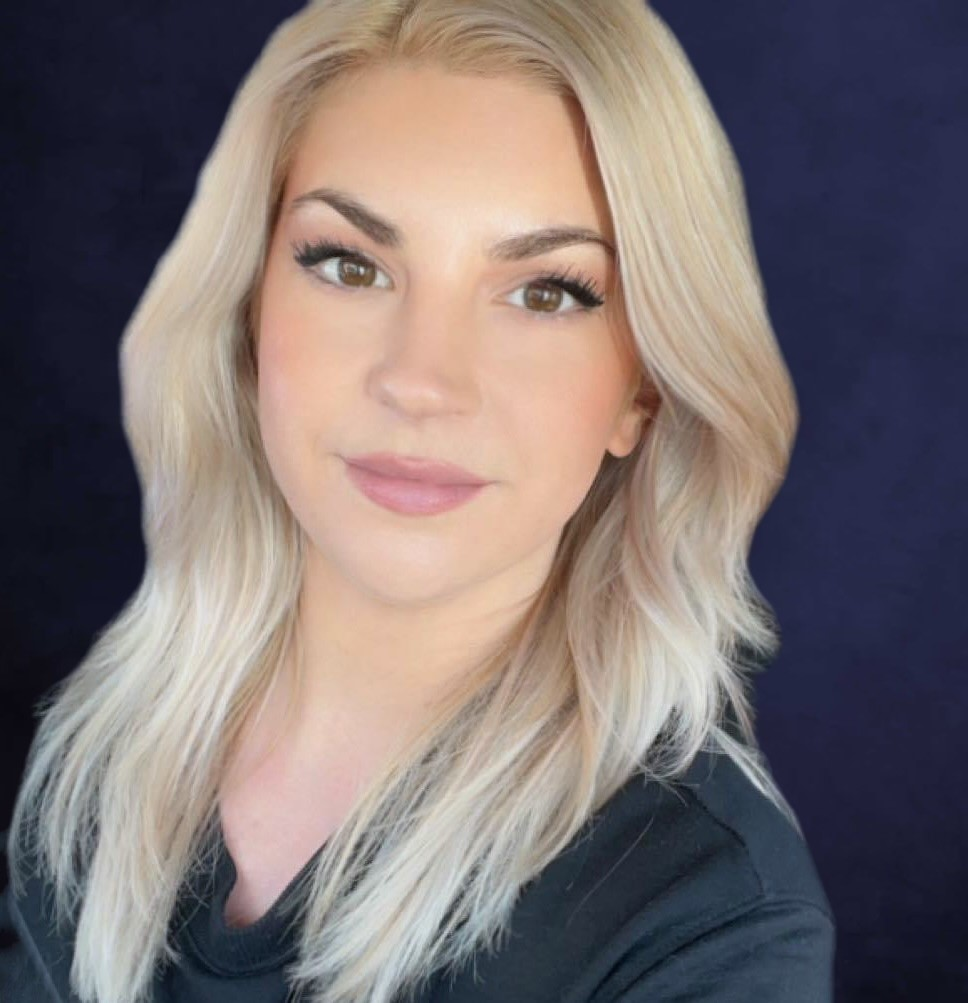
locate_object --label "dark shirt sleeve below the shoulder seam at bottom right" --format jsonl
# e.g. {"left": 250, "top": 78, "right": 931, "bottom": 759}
{"left": 596, "top": 900, "right": 835, "bottom": 1003}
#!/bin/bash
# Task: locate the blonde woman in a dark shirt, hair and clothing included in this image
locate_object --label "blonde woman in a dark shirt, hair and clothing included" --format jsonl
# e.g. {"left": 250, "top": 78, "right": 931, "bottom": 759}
{"left": 0, "top": 0, "right": 834, "bottom": 1003}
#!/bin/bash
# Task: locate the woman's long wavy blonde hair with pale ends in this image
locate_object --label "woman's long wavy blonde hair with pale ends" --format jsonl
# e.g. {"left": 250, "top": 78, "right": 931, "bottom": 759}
{"left": 9, "top": 0, "right": 798, "bottom": 1003}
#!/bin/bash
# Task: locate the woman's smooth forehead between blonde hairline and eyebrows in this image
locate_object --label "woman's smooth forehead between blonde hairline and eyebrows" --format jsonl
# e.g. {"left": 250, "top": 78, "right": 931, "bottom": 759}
{"left": 285, "top": 64, "right": 613, "bottom": 239}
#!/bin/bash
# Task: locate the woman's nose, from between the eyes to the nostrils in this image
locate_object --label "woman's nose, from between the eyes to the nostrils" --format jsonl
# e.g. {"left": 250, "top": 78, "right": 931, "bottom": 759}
{"left": 367, "top": 284, "right": 479, "bottom": 417}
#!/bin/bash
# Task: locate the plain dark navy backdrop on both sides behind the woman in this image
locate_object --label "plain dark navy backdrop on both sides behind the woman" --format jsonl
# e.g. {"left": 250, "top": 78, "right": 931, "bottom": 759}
{"left": 0, "top": 0, "right": 968, "bottom": 1003}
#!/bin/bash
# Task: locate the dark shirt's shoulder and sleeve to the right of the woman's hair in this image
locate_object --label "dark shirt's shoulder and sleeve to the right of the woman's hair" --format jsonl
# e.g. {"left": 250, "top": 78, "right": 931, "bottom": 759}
{"left": 427, "top": 752, "right": 834, "bottom": 1003}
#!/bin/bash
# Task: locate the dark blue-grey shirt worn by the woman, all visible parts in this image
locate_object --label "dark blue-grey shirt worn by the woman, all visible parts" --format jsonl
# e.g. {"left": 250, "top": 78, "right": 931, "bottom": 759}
{"left": 0, "top": 753, "right": 835, "bottom": 1003}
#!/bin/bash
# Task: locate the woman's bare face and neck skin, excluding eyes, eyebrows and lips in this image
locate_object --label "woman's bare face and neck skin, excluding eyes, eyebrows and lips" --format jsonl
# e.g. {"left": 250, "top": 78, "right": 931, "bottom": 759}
{"left": 224, "top": 65, "right": 645, "bottom": 915}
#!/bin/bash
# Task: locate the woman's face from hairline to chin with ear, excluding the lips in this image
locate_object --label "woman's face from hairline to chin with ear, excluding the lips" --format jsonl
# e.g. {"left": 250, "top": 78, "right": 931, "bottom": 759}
{"left": 257, "top": 65, "right": 640, "bottom": 605}
